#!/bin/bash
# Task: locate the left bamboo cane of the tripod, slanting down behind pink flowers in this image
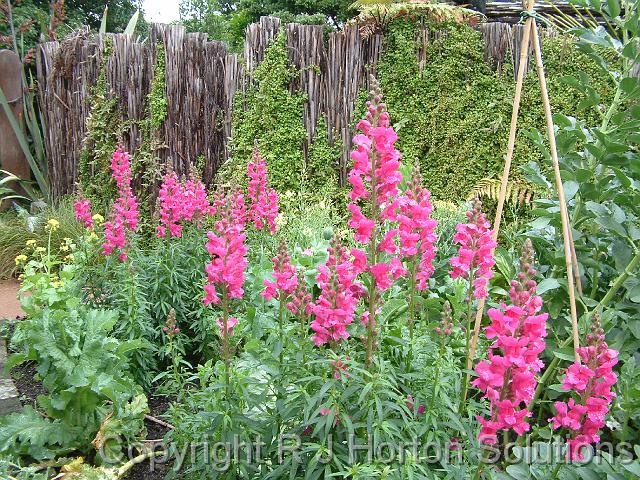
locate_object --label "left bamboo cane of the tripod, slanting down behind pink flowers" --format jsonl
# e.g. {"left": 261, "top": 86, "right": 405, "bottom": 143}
{"left": 462, "top": 0, "right": 534, "bottom": 376}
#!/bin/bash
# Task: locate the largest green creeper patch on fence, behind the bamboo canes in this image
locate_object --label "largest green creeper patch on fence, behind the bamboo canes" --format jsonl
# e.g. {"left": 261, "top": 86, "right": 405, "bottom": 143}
{"left": 377, "top": 18, "right": 611, "bottom": 200}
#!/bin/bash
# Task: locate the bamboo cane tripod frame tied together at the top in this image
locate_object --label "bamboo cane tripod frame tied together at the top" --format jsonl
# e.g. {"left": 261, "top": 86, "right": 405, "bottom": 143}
{"left": 467, "top": 0, "right": 582, "bottom": 372}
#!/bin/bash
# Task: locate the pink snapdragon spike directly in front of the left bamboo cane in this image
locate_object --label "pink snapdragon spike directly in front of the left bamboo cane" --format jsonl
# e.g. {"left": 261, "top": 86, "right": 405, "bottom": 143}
{"left": 451, "top": 200, "right": 497, "bottom": 299}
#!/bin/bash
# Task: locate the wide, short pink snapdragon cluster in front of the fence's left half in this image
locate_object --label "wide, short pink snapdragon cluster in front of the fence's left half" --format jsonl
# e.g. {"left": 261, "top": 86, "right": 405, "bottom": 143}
{"left": 156, "top": 171, "right": 211, "bottom": 238}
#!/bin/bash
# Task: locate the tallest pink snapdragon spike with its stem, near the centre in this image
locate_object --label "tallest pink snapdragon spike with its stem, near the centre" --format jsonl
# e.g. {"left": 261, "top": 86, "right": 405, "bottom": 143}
{"left": 347, "top": 80, "right": 406, "bottom": 365}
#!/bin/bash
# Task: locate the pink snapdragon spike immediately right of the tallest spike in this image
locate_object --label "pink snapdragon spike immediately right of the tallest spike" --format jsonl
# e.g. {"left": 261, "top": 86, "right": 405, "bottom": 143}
{"left": 396, "top": 168, "right": 438, "bottom": 290}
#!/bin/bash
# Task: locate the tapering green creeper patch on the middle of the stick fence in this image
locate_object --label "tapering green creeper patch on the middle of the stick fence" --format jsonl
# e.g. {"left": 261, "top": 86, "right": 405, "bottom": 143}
{"left": 218, "top": 32, "right": 340, "bottom": 208}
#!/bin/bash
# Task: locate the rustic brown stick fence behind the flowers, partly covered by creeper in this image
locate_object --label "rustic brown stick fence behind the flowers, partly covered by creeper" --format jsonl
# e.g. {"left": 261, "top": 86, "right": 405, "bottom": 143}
{"left": 37, "top": 17, "right": 544, "bottom": 198}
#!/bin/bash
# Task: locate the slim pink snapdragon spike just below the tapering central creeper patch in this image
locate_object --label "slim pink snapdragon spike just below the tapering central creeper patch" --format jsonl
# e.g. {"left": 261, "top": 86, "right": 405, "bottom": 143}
{"left": 247, "top": 148, "right": 278, "bottom": 234}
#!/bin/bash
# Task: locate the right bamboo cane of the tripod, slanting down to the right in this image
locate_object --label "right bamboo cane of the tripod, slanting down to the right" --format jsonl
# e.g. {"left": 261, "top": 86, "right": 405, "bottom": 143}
{"left": 532, "top": 18, "right": 580, "bottom": 361}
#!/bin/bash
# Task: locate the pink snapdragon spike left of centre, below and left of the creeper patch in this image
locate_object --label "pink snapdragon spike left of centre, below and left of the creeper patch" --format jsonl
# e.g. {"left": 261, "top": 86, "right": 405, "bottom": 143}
{"left": 203, "top": 192, "right": 247, "bottom": 305}
